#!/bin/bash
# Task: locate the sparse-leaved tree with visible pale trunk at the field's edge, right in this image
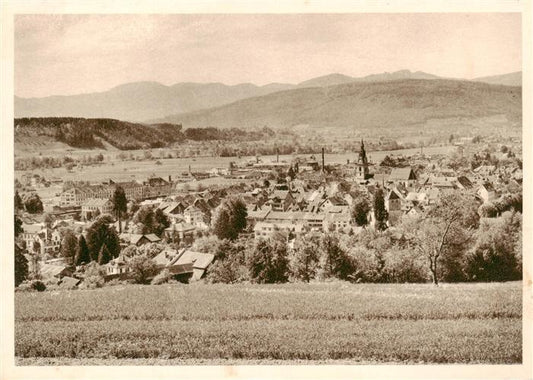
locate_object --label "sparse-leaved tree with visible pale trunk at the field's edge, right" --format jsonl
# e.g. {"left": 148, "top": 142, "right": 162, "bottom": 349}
{"left": 414, "top": 193, "right": 479, "bottom": 285}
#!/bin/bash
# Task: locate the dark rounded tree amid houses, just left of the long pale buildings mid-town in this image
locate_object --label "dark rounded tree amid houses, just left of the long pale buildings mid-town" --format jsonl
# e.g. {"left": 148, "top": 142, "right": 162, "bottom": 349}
{"left": 212, "top": 197, "right": 247, "bottom": 240}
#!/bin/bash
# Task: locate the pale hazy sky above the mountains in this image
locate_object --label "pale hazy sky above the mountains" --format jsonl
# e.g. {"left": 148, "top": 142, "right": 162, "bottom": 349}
{"left": 15, "top": 13, "right": 522, "bottom": 97}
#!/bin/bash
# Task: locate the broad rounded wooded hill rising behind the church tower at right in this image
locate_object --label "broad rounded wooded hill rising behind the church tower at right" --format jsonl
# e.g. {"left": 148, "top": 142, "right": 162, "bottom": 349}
{"left": 157, "top": 79, "right": 522, "bottom": 129}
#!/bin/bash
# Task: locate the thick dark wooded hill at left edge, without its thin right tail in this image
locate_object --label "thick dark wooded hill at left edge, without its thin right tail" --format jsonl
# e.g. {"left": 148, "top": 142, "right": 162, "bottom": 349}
{"left": 15, "top": 117, "right": 183, "bottom": 149}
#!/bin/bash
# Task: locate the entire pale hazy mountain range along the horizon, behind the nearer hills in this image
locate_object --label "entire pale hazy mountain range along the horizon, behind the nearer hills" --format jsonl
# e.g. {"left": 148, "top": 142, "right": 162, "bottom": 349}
{"left": 15, "top": 70, "right": 522, "bottom": 122}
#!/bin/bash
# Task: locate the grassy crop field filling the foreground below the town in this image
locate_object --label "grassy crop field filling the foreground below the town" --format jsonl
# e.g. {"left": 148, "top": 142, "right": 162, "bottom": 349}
{"left": 15, "top": 282, "right": 522, "bottom": 365}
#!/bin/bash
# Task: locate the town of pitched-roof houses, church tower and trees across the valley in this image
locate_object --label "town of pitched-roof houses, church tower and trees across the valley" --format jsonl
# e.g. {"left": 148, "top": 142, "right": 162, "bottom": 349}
{"left": 15, "top": 136, "right": 522, "bottom": 289}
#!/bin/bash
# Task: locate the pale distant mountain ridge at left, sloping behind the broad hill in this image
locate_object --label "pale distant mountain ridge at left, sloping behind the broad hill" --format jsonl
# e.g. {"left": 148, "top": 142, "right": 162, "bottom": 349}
{"left": 15, "top": 82, "right": 290, "bottom": 122}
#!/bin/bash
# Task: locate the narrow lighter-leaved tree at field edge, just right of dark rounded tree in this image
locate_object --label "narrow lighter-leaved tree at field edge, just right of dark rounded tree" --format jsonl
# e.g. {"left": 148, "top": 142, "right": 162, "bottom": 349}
{"left": 289, "top": 237, "right": 320, "bottom": 282}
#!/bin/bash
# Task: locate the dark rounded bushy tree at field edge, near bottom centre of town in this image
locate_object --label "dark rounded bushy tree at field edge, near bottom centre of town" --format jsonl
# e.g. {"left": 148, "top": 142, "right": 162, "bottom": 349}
{"left": 246, "top": 239, "right": 289, "bottom": 284}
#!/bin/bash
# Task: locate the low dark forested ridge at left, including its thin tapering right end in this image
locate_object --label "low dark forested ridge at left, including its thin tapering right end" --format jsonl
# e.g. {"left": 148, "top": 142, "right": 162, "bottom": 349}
{"left": 15, "top": 117, "right": 275, "bottom": 150}
